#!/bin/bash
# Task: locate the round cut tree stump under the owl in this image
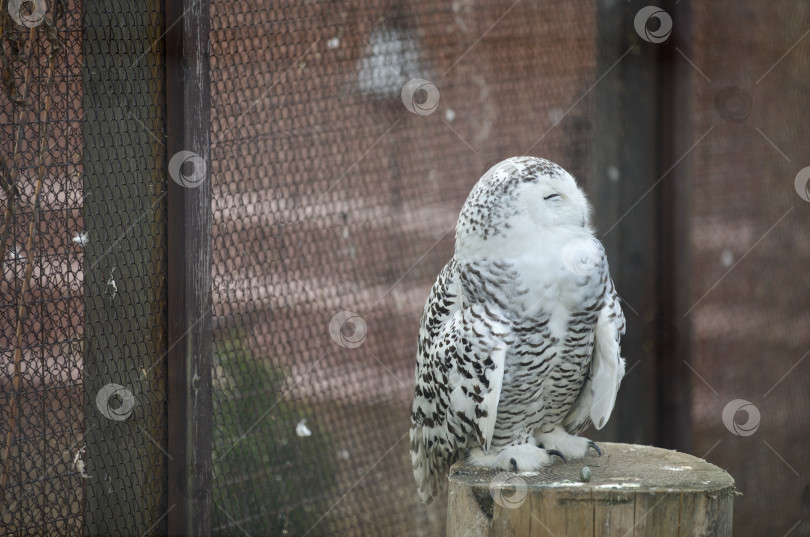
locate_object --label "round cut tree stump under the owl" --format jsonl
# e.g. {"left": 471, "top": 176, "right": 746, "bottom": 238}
{"left": 447, "top": 443, "right": 735, "bottom": 537}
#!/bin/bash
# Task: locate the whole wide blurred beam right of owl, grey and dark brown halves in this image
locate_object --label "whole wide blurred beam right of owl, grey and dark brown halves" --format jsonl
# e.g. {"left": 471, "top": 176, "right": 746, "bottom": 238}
{"left": 589, "top": 0, "right": 691, "bottom": 451}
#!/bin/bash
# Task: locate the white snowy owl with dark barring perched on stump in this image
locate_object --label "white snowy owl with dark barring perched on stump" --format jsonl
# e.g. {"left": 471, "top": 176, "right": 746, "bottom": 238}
{"left": 410, "top": 157, "right": 624, "bottom": 502}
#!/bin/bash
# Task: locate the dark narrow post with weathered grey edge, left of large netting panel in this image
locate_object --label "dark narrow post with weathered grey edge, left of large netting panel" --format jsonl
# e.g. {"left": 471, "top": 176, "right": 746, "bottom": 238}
{"left": 166, "top": 0, "right": 212, "bottom": 535}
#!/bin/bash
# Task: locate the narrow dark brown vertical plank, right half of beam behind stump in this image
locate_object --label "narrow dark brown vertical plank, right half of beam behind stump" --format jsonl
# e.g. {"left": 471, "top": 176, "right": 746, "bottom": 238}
{"left": 655, "top": 0, "right": 694, "bottom": 452}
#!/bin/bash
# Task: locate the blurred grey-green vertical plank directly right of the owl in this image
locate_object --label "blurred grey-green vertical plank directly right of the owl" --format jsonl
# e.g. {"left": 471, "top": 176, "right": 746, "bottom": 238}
{"left": 588, "top": 2, "right": 659, "bottom": 444}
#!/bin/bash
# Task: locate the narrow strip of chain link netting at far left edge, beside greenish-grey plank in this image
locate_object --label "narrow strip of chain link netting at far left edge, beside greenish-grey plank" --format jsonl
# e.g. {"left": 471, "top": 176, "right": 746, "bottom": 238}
{"left": 0, "top": 2, "right": 83, "bottom": 535}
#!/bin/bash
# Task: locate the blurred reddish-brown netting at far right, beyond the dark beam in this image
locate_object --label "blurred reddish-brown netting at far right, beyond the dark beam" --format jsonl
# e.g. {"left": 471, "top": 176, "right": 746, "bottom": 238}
{"left": 681, "top": 1, "right": 810, "bottom": 537}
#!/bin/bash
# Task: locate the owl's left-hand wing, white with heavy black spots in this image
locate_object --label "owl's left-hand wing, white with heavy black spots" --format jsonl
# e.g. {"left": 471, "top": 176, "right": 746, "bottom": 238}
{"left": 410, "top": 260, "right": 511, "bottom": 503}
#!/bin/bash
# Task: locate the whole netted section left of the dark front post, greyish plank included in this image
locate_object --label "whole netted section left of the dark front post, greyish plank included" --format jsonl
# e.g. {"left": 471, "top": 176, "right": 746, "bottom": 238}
{"left": 0, "top": 0, "right": 167, "bottom": 535}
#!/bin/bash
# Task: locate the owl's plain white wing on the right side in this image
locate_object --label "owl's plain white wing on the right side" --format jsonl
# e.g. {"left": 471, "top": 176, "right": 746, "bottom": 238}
{"left": 563, "top": 274, "right": 625, "bottom": 434}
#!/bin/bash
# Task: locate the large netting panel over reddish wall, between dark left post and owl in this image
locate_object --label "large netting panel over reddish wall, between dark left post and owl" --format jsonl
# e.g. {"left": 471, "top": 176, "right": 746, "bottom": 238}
{"left": 211, "top": 1, "right": 595, "bottom": 537}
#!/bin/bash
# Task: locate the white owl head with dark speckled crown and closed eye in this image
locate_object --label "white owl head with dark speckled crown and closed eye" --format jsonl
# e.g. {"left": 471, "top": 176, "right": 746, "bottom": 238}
{"left": 456, "top": 157, "right": 592, "bottom": 251}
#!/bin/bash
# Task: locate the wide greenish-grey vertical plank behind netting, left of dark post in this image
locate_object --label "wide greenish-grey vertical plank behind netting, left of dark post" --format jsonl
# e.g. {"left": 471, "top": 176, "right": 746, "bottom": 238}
{"left": 82, "top": 0, "right": 167, "bottom": 535}
